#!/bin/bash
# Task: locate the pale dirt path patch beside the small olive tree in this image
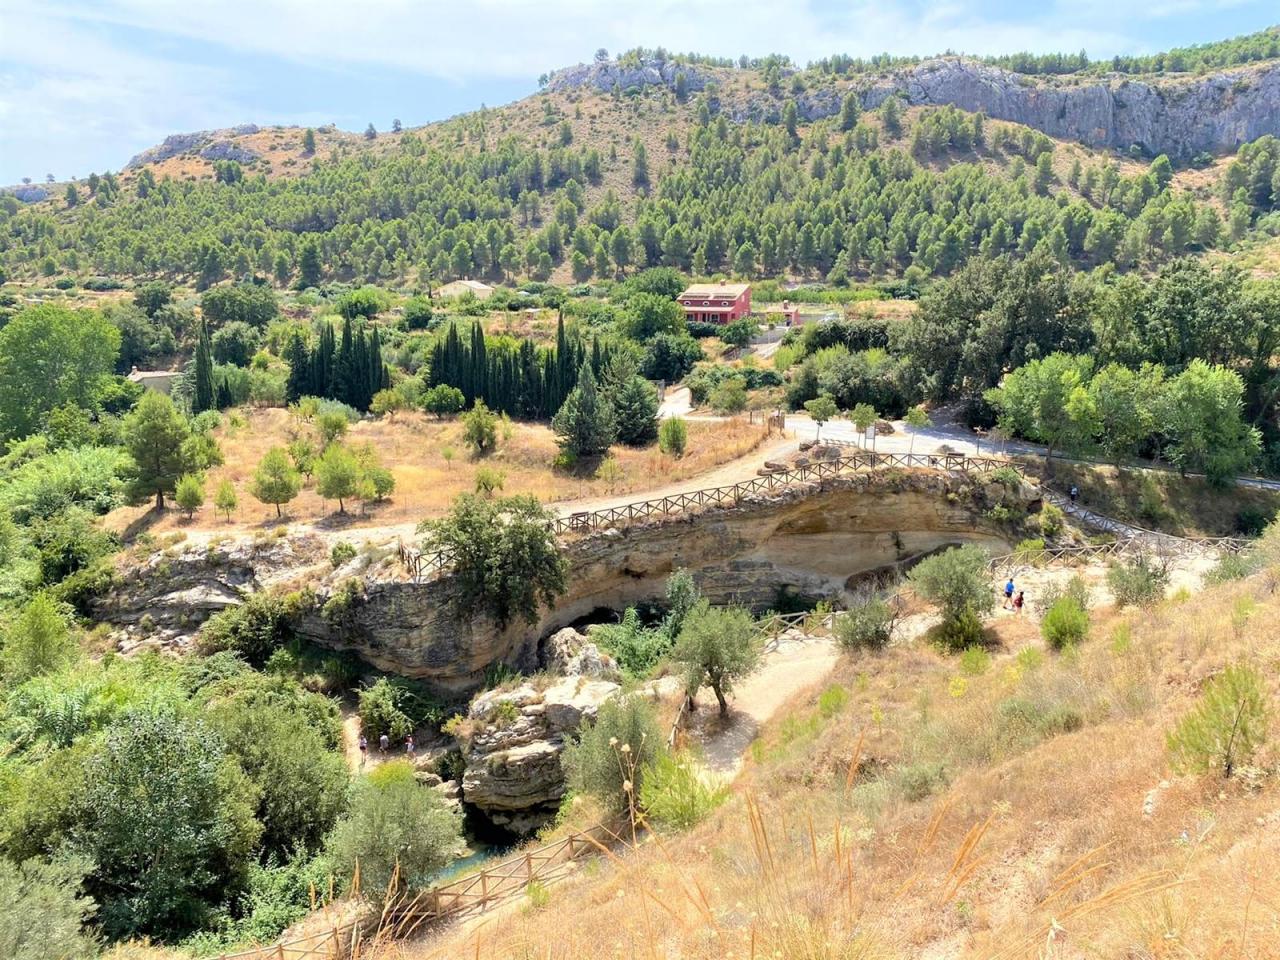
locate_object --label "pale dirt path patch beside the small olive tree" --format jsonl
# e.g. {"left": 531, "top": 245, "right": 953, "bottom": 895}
{"left": 686, "top": 636, "right": 838, "bottom": 780}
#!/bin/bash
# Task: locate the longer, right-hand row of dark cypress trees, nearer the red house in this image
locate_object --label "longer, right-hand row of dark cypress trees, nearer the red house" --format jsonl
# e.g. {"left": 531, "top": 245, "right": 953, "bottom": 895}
{"left": 428, "top": 320, "right": 612, "bottom": 420}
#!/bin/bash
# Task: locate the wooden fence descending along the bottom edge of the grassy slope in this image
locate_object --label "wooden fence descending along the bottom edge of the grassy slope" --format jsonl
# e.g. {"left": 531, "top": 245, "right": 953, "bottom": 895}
{"left": 214, "top": 823, "right": 628, "bottom": 960}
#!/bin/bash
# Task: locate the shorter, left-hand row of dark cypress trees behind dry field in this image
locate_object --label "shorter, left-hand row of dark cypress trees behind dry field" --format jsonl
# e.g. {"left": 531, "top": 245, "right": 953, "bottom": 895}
{"left": 284, "top": 319, "right": 390, "bottom": 410}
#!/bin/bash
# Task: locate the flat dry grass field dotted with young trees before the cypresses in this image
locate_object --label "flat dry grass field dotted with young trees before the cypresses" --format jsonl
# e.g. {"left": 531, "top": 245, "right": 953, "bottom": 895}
{"left": 106, "top": 408, "right": 767, "bottom": 534}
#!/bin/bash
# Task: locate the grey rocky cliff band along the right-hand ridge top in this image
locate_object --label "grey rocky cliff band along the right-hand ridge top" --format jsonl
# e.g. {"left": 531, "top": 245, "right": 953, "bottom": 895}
{"left": 548, "top": 56, "right": 1280, "bottom": 159}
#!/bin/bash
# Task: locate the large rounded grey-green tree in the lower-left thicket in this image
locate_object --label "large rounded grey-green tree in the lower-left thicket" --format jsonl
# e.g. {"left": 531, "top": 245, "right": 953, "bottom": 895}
{"left": 81, "top": 708, "right": 261, "bottom": 937}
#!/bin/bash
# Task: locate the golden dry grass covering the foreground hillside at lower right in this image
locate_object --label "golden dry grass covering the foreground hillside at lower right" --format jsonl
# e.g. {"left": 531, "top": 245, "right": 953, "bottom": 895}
{"left": 389, "top": 577, "right": 1280, "bottom": 960}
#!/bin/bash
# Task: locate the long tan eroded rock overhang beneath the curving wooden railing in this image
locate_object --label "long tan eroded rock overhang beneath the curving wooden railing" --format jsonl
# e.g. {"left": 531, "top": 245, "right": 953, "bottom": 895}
{"left": 298, "top": 471, "right": 1037, "bottom": 694}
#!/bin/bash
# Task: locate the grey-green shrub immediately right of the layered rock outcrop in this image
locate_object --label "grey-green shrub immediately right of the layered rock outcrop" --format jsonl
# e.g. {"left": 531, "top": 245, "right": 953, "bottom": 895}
{"left": 561, "top": 696, "right": 666, "bottom": 810}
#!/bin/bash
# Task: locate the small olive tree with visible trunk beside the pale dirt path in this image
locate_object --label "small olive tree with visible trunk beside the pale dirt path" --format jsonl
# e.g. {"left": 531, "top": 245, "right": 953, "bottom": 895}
{"left": 671, "top": 600, "right": 762, "bottom": 714}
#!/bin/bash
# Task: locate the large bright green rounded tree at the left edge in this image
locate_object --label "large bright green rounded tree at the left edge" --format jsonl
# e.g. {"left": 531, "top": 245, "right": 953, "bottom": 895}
{"left": 0, "top": 306, "right": 120, "bottom": 438}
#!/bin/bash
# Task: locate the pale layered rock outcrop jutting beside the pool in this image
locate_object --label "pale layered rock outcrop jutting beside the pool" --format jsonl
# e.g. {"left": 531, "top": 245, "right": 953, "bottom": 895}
{"left": 462, "top": 677, "right": 621, "bottom": 835}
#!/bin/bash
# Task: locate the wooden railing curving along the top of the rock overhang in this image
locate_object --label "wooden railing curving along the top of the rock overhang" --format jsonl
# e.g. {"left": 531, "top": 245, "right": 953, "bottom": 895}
{"left": 398, "top": 451, "right": 1021, "bottom": 581}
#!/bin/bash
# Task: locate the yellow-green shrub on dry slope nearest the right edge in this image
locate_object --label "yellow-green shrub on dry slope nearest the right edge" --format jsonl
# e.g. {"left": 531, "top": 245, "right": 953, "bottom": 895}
{"left": 1166, "top": 663, "right": 1267, "bottom": 777}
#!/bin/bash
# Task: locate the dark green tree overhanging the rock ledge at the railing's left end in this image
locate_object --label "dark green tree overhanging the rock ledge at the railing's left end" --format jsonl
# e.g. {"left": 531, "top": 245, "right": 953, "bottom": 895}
{"left": 419, "top": 494, "right": 568, "bottom": 625}
